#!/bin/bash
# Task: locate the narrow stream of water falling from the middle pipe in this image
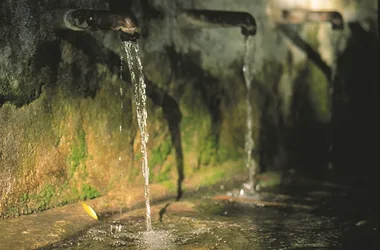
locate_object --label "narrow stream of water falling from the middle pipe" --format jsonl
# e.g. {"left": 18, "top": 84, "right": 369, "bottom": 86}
{"left": 243, "top": 36, "right": 257, "bottom": 192}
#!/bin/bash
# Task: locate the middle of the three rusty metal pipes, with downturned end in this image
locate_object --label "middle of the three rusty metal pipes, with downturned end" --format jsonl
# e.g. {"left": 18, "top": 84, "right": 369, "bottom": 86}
{"left": 177, "top": 9, "right": 257, "bottom": 36}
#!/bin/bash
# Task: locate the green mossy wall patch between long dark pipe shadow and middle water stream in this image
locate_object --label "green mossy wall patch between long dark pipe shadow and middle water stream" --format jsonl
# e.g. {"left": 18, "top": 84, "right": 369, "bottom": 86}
{"left": 180, "top": 74, "right": 245, "bottom": 169}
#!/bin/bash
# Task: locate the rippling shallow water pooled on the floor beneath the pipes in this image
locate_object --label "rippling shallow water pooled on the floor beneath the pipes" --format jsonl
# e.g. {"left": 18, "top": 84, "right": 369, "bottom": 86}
{"left": 43, "top": 182, "right": 379, "bottom": 250}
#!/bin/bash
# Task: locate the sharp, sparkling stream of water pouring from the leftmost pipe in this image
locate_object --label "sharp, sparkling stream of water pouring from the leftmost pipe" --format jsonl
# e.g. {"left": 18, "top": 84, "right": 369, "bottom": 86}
{"left": 124, "top": 42, "right": 152, "bottom": 231}
